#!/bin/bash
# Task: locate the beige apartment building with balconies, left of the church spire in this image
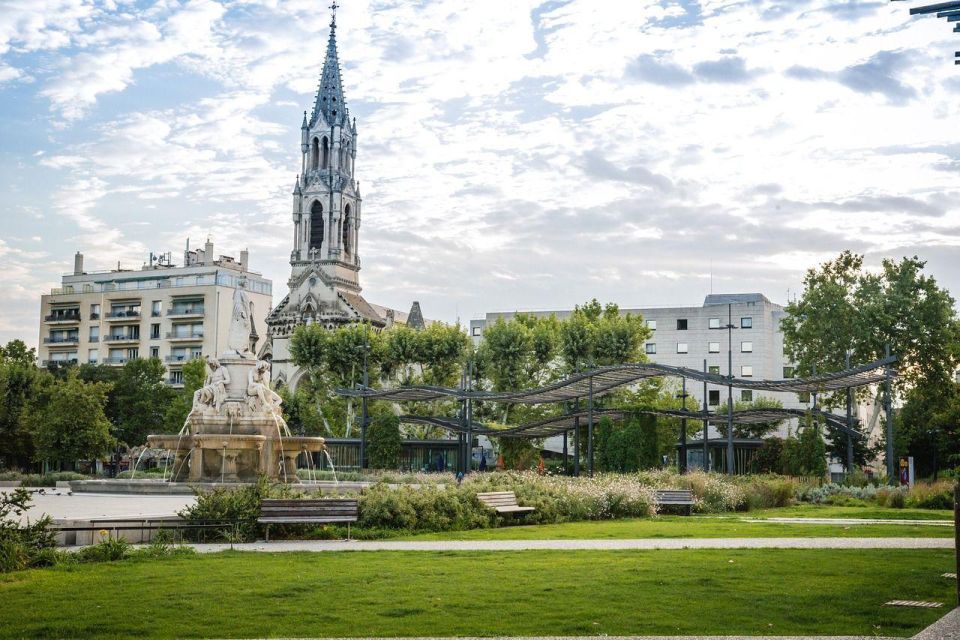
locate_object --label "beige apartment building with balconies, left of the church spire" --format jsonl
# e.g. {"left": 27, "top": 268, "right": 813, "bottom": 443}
{"left": 39, "top": 240, "right": 273, "bottom": 386}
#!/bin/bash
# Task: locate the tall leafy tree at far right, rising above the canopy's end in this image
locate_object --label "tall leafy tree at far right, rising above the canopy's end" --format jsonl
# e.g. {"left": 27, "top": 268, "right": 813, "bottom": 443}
{"left": 780, "top": 251, "right": 960, "bottom": 467}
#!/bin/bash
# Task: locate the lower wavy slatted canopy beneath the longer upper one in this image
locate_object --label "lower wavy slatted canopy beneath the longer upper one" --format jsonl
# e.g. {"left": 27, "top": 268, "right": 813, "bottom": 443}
{"left": 400, "top": 408, "right": 864, "bottom": 438}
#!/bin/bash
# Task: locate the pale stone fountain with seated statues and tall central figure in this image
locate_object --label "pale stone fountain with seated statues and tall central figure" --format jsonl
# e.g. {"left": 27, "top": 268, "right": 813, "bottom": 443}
{"left": 147, "top": 284, "right": 324, "bottom": 482}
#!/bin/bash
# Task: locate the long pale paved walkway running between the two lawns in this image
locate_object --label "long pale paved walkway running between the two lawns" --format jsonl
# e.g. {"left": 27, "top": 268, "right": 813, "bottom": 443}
{"left": 192, "top": 538, "right": 953, "bottom": 553}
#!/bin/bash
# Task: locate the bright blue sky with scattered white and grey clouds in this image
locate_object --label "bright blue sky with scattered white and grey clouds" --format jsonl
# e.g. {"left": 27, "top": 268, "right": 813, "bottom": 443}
{"left": 0, "top": 0, "right": 960, "bottom": 345}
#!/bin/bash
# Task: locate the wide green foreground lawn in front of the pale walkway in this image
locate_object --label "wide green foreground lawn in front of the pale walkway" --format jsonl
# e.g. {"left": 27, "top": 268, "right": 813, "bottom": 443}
{"left": 0, "top": 550, "right": 953, "bottom": 638}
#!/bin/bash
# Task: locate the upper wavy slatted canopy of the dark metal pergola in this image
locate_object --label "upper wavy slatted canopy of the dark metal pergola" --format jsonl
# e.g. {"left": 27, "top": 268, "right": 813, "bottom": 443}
{"left": 337, "top": 356, "right": 897, "bottom": 404}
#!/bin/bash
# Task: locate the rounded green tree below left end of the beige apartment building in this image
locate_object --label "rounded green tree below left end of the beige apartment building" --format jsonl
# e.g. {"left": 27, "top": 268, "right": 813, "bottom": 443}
{"left": 26, "top": 370, "right": 116, "bottom": 465}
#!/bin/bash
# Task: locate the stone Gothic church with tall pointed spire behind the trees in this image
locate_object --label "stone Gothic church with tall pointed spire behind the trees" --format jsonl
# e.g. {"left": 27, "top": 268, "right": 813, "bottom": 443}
{"left": 259, "top": 10, "right": 424, "bottom": 387}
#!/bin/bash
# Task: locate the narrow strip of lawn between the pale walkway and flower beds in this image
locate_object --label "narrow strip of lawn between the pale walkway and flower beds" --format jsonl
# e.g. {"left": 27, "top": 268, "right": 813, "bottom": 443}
{"left": 400, "top": 512, "right": 953, "bottom": 540}
